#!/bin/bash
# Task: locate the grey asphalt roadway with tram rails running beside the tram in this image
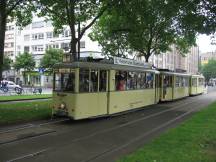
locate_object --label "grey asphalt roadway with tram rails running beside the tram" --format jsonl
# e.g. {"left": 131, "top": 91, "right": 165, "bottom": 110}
{"left": 0, "top": 88, "right": 216, "bottom": 162}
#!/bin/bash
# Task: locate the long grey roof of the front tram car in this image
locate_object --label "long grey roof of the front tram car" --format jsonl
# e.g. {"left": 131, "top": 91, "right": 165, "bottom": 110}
{"left": 54, "top": 62, "right": 160, "bottom": 73}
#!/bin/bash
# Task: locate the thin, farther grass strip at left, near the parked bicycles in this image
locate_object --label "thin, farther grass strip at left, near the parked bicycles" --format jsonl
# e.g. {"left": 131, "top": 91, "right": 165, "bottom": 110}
{"left": 0, "top": 94, "right": 52, "bottom": 101}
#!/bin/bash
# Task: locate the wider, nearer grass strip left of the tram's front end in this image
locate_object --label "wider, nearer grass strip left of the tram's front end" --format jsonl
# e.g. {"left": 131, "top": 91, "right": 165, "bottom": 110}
{"left": 0, "top": 101, "right": 52, "bottom": 125}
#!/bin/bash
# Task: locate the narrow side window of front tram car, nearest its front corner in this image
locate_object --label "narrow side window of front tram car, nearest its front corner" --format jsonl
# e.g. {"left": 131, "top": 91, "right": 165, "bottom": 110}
{"left": 79, "top": 69, "right": 89, "bottom": 92}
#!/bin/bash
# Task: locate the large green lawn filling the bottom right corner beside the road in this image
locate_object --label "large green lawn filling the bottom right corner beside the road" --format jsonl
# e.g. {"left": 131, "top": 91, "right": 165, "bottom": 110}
{"left": 118, "top": 103, "right": 216, "bottom": 162}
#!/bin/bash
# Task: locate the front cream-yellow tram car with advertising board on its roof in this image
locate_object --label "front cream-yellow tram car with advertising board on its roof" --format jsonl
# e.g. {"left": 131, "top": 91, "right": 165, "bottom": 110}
{"left": 53, "top": 58, "right": 160, "bottom": 120}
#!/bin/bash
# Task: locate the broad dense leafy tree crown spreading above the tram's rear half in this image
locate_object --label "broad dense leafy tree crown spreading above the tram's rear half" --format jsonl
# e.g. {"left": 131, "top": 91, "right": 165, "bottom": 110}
{"left": 91, "top": 0, "right": 215, "bottom": 62}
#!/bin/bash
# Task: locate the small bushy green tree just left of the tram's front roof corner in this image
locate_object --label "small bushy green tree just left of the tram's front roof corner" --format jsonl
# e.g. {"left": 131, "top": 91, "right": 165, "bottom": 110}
{"left": 40, "top": 48, "right": 64, "bottom": 72}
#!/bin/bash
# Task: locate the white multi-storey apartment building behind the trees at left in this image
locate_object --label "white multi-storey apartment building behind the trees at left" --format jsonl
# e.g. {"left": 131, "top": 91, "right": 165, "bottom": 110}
{"left": 3, "top": 17, "right": 101, "bottom": 86}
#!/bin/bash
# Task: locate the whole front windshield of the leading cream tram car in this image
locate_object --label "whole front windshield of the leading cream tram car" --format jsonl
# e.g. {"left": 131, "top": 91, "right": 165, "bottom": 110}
{"left": 54, "top": 71, "right": 75, "bottom": 92}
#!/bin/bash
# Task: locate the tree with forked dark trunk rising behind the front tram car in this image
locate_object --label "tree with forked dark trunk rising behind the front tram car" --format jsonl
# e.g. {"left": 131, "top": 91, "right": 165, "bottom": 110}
{"left": 38, "top": 0, "right": 115, "bottom": 60}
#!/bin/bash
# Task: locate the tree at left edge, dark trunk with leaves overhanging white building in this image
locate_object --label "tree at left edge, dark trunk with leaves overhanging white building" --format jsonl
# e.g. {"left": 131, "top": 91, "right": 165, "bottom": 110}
{"left": 0, "top": 0, "right": 35, "bottom": 80}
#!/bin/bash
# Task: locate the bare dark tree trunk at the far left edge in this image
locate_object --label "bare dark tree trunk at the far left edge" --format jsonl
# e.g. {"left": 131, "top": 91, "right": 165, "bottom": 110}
{"left": 0, "top": 0, "right": 7, "bottom": 80}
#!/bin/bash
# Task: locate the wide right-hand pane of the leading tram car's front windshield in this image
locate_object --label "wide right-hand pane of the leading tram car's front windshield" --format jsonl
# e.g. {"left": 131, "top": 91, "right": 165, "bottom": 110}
{"left": 62, "top": 72, "right": 75, "bottom": 92}
